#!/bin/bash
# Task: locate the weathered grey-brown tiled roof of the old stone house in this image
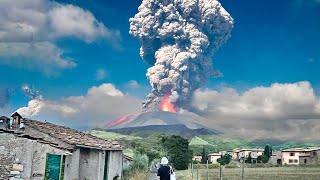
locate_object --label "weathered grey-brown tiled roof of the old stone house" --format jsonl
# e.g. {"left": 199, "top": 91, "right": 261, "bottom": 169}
{"left": 24, "top": 119, "right": 122, "bottom": 150}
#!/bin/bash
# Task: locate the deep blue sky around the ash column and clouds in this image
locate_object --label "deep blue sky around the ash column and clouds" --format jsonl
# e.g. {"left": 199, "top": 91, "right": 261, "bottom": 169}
{"left": 0, "top": 0, "right": 320, "bottom": 138}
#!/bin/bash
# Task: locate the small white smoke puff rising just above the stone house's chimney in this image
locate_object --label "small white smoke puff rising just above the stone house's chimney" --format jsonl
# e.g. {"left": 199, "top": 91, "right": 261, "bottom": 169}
{"left": 17, "top": 85, "right": 45, "bottom": 116}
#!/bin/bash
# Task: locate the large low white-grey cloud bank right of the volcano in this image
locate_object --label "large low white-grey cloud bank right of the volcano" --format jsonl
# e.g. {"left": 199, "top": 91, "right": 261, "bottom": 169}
{"left": 193, "top": 81, "right": 320, "bottom": 139}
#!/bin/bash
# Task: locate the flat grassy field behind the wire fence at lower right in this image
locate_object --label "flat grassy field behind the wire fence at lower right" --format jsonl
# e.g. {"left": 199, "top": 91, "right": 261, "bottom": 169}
{"left": 176, "top": 167, "right": 320, "bottom": 180}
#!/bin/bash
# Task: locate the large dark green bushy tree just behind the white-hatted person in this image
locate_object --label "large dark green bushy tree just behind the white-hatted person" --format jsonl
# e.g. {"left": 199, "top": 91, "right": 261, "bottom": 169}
{"left": 161, "top": 135, "right": 193, "bottom": 170}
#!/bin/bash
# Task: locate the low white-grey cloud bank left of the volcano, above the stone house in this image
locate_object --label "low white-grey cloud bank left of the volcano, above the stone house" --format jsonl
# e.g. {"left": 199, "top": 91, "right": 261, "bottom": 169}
{"left": 19, "top": 84, "right": 141, "bottom": 127}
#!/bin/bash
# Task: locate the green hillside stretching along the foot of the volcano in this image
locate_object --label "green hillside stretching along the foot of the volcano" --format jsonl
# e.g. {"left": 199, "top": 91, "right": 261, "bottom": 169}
{"left": 89, "top": 130, "right": 320, "bottom": 155}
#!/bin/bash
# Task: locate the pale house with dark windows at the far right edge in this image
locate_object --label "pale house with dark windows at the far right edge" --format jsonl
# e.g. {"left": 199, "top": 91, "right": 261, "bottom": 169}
{"left": 281, "top": 147, "right": 320, "bottom": 165}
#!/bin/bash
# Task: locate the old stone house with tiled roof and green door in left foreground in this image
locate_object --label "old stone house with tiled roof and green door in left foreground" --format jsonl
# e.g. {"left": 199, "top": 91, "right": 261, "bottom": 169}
{"left": 0, "top": 113, "right": 123, "bottom": 180}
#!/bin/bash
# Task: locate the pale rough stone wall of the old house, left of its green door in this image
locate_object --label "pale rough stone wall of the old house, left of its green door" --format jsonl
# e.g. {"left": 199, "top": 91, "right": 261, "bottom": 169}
{"left": 0, "top": 133, "right": 66, "bottom": 180}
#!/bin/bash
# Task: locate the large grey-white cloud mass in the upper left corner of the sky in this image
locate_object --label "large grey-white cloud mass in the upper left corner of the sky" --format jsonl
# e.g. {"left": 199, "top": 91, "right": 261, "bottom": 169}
{"left": 0, "top": 0, "right": 120, "bottom": 71}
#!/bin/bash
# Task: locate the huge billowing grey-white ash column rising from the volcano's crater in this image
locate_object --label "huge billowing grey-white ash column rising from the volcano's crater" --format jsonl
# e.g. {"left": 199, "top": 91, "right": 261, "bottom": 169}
{"left": 130, "top": 0, "right": 233, "bottom": 110}
